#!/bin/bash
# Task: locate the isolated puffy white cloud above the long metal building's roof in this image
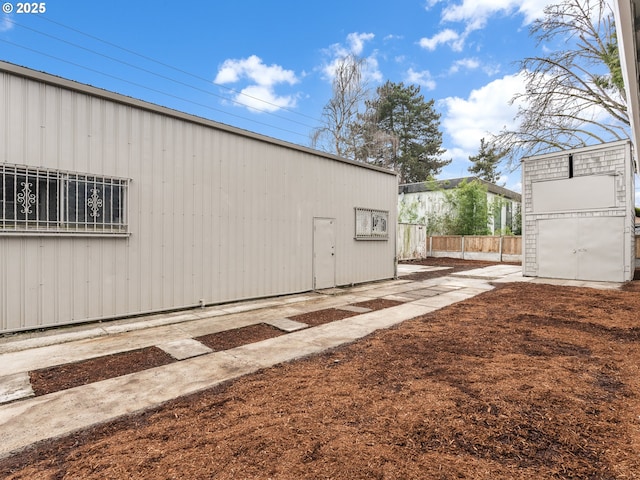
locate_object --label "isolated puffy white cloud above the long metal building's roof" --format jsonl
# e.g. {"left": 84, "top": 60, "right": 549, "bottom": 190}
{"left": 214, "top": 55, "right": 298, "bottom": 112}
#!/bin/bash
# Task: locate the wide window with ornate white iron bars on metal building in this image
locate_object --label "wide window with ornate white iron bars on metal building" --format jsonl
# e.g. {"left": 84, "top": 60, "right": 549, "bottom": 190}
{"left": 0, "top": 164, "right": 129, "bottom": 234}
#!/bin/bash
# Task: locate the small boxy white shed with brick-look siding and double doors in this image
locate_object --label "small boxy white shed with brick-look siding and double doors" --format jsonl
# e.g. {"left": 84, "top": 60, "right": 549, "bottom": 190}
{"left": 522, "top": 140, "right": 635, "bottom": 282}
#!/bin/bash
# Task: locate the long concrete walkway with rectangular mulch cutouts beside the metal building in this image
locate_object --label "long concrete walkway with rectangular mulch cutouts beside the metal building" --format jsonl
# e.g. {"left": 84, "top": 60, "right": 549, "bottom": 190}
{"left": 0, "top": 265, "right": 620, "bottom": 458}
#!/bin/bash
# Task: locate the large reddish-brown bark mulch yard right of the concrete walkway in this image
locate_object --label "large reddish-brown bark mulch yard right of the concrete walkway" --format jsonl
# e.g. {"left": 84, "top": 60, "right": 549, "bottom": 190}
{"left": 0, "top": 259, "right": 640, "bottom": 480}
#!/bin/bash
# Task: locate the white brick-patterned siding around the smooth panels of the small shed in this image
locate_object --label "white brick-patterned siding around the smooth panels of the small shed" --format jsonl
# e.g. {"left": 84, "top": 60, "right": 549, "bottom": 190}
{"left": 522, "top": 142, "right": 635, "bottom": 276}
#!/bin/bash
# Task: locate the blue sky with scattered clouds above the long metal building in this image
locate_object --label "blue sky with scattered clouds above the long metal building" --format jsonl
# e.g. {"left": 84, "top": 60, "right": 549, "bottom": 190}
{"left": 0, "top": 0, "right": 632, "bottom": 195}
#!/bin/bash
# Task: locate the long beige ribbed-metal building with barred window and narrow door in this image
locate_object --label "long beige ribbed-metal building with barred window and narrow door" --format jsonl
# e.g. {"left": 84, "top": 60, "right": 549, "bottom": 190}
{"left": 0, "top": 62, "right": 397, "bottom": 332}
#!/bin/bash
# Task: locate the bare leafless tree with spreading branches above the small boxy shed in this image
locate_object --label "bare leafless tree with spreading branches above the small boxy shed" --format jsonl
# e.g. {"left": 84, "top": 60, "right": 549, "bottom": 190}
{"left": 493, "top": 0, "right": 629, "bottom": 166}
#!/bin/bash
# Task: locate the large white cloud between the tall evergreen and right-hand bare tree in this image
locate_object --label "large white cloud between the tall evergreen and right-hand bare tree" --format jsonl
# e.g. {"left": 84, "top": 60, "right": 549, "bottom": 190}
{"left": 442, "top": 74, "right": 524, "bottom": 154}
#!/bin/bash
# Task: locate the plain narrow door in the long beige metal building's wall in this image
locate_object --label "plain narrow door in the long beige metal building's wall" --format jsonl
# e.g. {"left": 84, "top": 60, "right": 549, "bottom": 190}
{"left": 313, "top": 218, "right": 336, "bottom": 289}
